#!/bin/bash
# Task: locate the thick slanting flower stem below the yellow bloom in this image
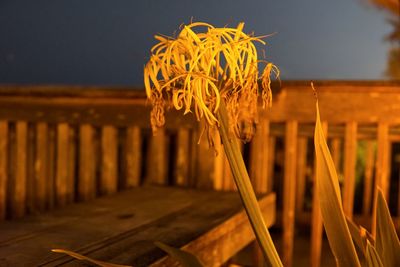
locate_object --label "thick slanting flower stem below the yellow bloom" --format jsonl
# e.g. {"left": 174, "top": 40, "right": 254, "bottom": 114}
{"left": 218, "top": 101, "right": 283, "bottom": 267}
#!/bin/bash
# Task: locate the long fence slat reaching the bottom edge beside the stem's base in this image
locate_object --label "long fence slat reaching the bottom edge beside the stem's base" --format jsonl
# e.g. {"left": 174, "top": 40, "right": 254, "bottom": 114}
{"left": 282, "top": 121, "right": 298, "bottom": 266}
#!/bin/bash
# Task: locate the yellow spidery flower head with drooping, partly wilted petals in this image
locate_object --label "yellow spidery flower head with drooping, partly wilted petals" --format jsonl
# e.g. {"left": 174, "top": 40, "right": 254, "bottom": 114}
{"left": 144, "top": 22, "right": 279, "bottom": 143}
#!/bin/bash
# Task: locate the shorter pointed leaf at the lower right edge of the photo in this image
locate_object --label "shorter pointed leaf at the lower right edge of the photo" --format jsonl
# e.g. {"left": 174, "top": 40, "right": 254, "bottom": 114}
{"left": 375, "top": 190, "right": 400, "bottom": 267}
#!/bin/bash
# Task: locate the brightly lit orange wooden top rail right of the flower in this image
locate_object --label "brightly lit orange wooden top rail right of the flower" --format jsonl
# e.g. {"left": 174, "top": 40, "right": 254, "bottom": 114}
{"left": 266, "top": 82, "right": 400, "bottom": 124}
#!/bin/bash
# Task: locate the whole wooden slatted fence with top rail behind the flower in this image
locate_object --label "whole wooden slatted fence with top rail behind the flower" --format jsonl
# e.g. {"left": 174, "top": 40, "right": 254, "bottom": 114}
{"left": 0, "top": 82, "right": 400, "bottom": 266}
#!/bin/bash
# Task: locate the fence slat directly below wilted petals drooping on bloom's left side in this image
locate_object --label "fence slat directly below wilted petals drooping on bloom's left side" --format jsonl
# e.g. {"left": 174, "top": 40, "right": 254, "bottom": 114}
{"left": 174, "top": 128, "right": 190, "bottom": 186}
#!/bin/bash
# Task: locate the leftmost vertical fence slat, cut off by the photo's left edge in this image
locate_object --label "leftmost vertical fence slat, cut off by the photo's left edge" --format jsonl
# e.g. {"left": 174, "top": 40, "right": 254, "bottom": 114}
{"left": 0, "top": 121, "right": 9, "bottom": 220}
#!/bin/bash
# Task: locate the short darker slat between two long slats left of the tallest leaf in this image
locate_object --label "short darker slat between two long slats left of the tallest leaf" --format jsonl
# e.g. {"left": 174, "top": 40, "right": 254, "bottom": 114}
{"left": 296, "top": 137, "right": 308, "bottom": 214}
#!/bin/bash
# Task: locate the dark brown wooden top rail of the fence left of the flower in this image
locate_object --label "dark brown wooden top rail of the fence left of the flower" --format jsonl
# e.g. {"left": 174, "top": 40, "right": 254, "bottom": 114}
{"left": 0, "top": 86, "right": 195, "bottom": 128}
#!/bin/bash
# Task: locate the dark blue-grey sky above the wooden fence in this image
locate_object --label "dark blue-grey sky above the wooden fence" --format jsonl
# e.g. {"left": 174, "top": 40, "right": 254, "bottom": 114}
{"left": 0, "top": 0, "right": 391, "bottom": 86}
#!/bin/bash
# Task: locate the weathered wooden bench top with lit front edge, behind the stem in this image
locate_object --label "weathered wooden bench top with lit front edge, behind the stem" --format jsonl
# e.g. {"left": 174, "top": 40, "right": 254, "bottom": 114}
{"left": 0, "top": 187, "right": 275, "bottom": 266}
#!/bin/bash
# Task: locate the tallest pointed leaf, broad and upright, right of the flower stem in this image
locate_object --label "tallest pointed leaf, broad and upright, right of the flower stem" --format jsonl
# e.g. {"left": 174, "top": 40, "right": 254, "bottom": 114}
{"left": 314, "top": 101, "right": 360, "bottom": 267}
